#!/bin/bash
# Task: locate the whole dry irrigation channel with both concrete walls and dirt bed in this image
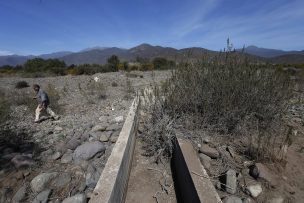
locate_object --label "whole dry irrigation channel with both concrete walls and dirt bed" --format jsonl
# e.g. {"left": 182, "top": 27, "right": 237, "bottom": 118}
{"left": 90, "top": 96, "right": 222, "bottom": 203}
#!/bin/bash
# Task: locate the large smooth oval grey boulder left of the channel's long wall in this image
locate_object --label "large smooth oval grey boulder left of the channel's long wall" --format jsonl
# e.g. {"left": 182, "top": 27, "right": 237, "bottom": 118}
{"left": 73, "top": 141, "right": 106, "bottom": 160}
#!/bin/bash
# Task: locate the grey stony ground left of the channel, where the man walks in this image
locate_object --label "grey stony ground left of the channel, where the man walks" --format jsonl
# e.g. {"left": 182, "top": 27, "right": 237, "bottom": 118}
{"left": 0, "top": 72, "right": 168, "bottom": 203}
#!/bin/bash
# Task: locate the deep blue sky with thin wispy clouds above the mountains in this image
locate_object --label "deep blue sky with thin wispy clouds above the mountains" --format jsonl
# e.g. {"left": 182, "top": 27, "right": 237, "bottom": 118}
{"left": 0, "top": 0, "right": 304, "bottom": 55}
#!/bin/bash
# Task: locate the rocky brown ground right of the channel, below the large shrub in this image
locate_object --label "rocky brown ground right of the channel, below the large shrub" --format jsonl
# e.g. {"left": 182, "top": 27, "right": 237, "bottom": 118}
{"left": 176, "top": 89, "right": 304, "bottom": 203}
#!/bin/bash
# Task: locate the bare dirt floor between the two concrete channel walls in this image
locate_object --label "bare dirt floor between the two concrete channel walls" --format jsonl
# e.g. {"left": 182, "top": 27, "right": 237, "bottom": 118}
{"left": 125, "top": 138, "right": 176, "bottom": 203}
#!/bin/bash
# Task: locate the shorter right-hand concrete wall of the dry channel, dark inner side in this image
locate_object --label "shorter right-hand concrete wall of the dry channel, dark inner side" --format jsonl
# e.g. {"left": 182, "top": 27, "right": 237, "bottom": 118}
{"left": 176, "top": 139, "right": 222, "bottom": 203}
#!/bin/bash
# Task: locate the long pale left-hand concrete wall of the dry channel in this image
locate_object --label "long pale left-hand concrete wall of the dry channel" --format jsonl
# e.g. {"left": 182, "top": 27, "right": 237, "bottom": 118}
{"left": 89, "top": 96, "right": 140, "bottom": 203}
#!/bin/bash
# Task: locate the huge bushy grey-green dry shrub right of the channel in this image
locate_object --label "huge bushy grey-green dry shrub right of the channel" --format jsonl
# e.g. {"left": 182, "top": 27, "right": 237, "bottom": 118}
{"left": 146, "top": 52, "right": 292, "bottom": 163}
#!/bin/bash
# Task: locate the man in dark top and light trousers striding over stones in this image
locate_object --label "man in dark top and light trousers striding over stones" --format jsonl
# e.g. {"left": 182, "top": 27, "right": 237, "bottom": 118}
{"left": 33, "top": 84, "right": 59, "bottom": 123}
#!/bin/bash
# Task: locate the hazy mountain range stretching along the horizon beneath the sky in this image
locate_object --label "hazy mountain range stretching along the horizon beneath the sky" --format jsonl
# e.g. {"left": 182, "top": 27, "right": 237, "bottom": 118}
{"left": 0, "top": 44, "right": 304, "bottom": 66}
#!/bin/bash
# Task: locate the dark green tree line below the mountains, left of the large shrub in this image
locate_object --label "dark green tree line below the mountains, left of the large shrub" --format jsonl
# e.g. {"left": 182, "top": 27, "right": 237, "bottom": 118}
{"left": 0, "top": 55, "right": 176, "bottom": 77}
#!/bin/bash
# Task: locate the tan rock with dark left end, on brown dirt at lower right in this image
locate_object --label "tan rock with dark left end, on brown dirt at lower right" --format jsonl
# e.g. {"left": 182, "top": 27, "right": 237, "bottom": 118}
{"left": 249, "top": 163, "right": 279, "bottom": 187}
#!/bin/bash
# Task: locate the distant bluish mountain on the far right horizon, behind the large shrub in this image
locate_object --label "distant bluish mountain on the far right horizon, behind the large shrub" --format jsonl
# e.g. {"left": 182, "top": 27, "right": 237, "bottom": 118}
{"left": 238, "top": 46, "right": 304, "bottom": 58}
